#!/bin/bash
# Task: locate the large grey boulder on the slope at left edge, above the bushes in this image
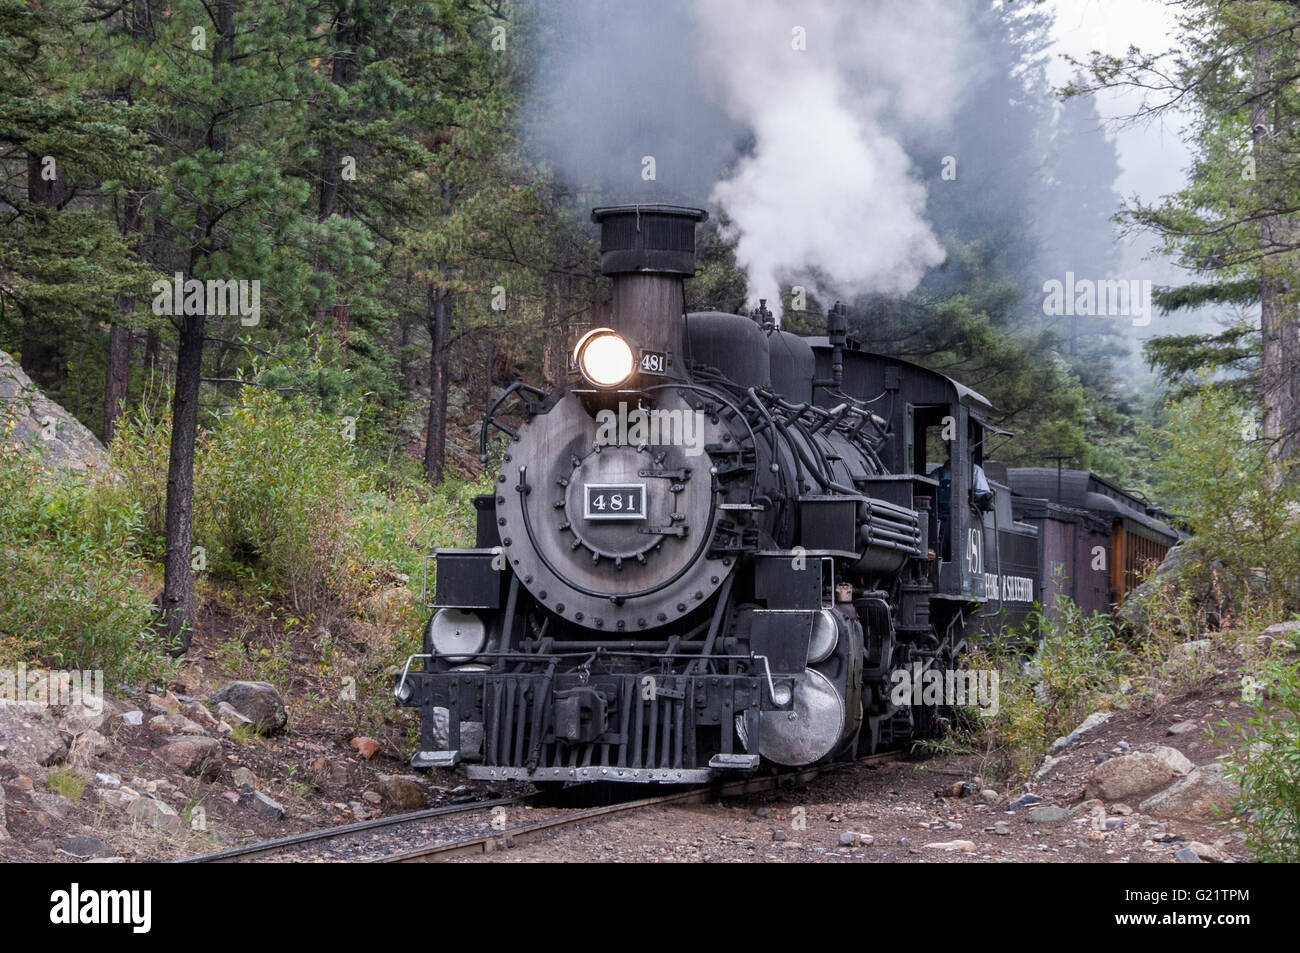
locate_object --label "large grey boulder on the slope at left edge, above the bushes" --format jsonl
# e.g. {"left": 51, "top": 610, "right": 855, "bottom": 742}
{"left": 0, "top": 351, "right": 112, "bottom": 473}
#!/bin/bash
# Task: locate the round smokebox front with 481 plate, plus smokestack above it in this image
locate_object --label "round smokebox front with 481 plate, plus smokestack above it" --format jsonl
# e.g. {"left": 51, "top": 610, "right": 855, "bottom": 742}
{"left": 497, "top": 205, "right": 737, "bottom": 633}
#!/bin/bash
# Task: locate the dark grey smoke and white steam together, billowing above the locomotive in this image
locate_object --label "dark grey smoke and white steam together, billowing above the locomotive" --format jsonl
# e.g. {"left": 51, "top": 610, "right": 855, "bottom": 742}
{"left": 527, "top": 0, "right": 970, "bottom": 313}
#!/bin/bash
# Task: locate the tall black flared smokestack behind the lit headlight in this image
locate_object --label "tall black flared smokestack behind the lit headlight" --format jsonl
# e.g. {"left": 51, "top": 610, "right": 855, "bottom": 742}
{"left": 592, "top": 205, "right": 709, "bottom": 377}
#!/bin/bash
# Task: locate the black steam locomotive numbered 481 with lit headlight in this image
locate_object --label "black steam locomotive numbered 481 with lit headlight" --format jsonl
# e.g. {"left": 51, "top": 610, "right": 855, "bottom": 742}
{"left": 395, "top": 205, "right": 1175, "bottom": 784}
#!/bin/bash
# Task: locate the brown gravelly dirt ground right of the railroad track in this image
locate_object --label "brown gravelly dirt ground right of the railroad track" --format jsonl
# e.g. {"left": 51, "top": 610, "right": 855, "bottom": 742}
{"left": 462, "top": 680, "right": 1249, "bottom": 863}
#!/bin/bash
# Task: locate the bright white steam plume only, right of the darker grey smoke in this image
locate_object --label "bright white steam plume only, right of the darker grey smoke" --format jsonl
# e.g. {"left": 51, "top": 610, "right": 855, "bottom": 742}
{"left": 694, "top": 0, "right": 961, "bottom": 313}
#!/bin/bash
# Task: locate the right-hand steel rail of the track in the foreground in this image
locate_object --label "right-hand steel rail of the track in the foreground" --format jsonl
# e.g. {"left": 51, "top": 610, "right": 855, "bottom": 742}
{"left": 368, "top": 751, "right": 900, "bottom": 863}
